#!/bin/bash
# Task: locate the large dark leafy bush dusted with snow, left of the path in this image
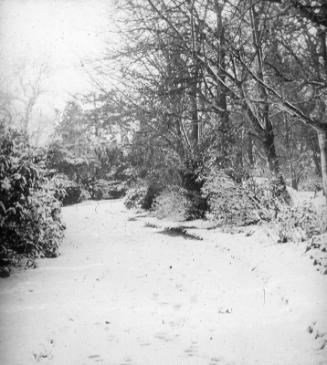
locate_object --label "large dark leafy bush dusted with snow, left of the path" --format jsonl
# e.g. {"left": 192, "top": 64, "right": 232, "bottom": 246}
{"left": 0, "top": 134, "right": 64, "bottom": 267}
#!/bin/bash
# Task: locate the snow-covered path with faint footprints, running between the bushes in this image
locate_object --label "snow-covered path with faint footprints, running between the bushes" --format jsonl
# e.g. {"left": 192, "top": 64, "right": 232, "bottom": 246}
{"left": 0, "top": 201, "right": 327, "bottom": 365}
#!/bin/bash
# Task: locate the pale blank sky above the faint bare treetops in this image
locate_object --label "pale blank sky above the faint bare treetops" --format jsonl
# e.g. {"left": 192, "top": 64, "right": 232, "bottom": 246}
{"left": 0, "top": 0, "right": 116, "bottom": 108}
